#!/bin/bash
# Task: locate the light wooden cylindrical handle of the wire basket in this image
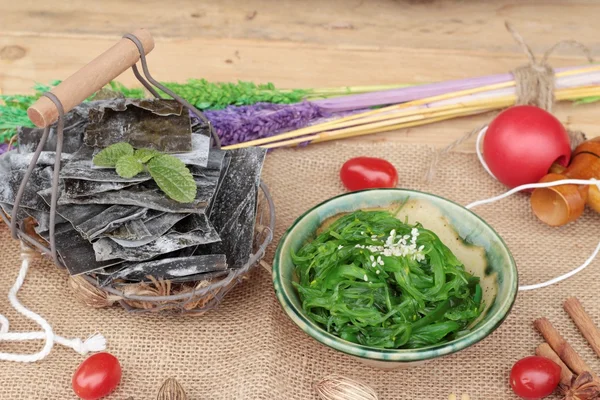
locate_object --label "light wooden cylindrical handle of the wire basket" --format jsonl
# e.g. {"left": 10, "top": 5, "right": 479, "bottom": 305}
{"left": 27, "top": 29, "right": 154, "bottom": 128}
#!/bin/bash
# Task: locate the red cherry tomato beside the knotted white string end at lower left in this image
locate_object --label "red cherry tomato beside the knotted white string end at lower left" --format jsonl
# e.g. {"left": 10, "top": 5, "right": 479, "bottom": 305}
{"left": 72, "top": 353, "right": 121, "bottom": 400}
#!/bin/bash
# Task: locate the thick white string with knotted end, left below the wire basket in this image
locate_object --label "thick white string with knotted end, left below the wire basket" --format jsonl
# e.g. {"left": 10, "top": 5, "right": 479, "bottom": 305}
{"left": 0, "top": 259, "right": 106, "bottom": 363}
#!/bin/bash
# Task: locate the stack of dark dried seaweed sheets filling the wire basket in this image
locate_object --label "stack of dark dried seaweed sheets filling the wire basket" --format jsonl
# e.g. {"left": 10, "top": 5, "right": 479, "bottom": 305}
{"left": 0, "top": 98, "right": 265, "bottom": 286}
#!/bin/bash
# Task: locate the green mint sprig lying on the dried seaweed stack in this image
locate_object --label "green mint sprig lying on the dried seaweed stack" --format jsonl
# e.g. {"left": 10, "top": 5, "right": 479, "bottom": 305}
{"left": 93, "top": 142, "right": 197, "bottom": 203}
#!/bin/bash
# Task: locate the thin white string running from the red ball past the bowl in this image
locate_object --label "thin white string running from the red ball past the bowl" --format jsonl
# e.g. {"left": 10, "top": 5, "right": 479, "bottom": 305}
{"left": 472, "top": 126, "right": 600, "bottom": 291}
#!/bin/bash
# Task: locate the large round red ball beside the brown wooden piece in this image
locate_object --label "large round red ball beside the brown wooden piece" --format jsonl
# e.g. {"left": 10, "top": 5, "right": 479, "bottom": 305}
{"left": 483, "top": 106, "right": 571, "bottom": 188}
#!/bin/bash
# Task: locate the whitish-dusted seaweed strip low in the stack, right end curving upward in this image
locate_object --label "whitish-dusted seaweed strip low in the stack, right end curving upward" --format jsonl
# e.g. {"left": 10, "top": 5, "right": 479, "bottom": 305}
{"left": 94, "top": 214, "right": 220, "bottom": 261}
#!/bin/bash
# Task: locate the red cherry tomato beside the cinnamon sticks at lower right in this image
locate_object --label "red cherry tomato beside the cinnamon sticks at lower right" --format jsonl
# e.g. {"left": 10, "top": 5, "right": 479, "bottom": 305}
{"left": 510, "top": 356, "right": 560, "bottom": 400}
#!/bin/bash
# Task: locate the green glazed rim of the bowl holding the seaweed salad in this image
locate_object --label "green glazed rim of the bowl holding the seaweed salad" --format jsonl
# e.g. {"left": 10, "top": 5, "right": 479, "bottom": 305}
{"left": 272, "top": 188, "right": 519, "bottom": 362}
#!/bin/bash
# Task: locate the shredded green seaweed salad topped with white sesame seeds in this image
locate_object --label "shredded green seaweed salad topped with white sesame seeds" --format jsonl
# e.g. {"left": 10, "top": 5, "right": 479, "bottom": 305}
{"left": 292, "top": 211, "right": 484, "bottom": 349}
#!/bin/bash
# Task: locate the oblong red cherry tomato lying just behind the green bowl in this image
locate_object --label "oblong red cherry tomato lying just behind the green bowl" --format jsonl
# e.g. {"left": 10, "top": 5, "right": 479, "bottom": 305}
{"left": 340, "top": 157, "right": 398, "bottom": 191}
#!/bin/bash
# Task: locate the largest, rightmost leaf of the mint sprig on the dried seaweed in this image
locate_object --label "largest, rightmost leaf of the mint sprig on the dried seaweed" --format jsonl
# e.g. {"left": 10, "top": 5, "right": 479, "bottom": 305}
{"left": 148, "top": 155, "right": 197, "bottom": 203}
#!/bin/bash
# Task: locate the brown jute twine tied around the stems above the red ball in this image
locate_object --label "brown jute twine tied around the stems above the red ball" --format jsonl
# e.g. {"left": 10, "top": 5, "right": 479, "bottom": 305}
{"left": 425, "top": 22, "right": 594, "bottom": 183}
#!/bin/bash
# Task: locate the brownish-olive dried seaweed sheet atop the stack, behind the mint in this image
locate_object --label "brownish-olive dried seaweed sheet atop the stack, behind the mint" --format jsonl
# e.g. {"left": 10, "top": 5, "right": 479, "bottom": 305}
{"left": 84, "top": 99, "right": 192, "bottom": 153}
